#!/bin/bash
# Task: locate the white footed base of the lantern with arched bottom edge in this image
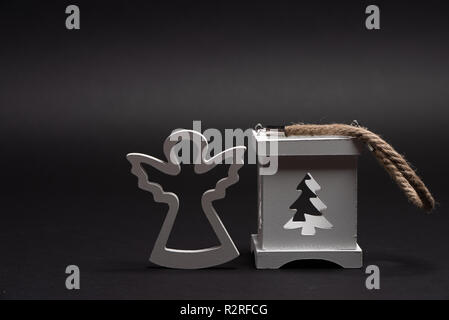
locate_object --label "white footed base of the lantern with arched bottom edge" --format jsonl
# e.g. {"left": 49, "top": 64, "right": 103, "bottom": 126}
{"left": 251, "top": 234, "right": 362, "bottom": 269}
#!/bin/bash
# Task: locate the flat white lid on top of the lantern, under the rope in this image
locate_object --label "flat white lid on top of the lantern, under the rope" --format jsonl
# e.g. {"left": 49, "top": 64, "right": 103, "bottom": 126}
{"left": 250, "top": 129, "right": 362, "bottom": 156}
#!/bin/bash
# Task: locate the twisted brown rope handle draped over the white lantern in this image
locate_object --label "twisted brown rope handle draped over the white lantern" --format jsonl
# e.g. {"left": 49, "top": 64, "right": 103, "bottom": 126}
{"left": 284, "top": 124, "right": 435, "bottom": 211}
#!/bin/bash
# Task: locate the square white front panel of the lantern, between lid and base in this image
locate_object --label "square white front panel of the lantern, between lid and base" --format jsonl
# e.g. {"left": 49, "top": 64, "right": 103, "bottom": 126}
{"left": 259, "top": 156, "right": 357, "bottom": 250}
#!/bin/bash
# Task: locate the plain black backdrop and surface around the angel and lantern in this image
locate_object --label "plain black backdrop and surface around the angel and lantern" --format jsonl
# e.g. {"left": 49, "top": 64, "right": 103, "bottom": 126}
{"left": 0, "top": 1, "right": 449, "bottom": 299}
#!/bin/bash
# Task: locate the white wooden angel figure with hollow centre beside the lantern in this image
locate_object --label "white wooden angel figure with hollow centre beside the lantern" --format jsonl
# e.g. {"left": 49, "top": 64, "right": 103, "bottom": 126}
{"left": 126, "top": 130, "right": 246, "bottom": 269}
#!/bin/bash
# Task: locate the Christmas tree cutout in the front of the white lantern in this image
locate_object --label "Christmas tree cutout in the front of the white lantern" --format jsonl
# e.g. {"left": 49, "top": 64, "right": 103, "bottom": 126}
{"left": 284, "top": 173, "right": 332, "bottom": 236}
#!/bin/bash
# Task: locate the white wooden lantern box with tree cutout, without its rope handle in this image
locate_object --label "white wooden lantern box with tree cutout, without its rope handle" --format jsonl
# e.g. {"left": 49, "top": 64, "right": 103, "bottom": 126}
{"left": 251, "top": 129, "right": 362, "bottom": 269}
